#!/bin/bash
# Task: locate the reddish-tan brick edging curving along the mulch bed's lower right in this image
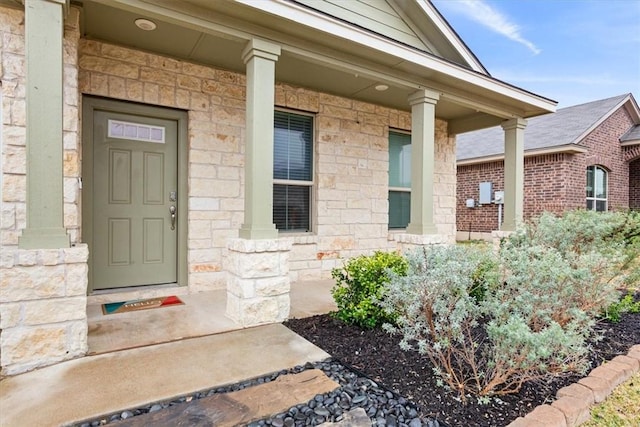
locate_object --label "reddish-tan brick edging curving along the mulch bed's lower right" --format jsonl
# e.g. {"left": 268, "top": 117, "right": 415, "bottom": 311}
{"left": 507, "top": 344, "right": 640, "bottom": 427}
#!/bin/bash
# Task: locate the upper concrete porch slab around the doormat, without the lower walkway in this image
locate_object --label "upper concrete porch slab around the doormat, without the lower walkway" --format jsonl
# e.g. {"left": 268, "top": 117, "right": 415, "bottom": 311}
{"left": 87, "top": 280, "right": 336, "bottom": 355}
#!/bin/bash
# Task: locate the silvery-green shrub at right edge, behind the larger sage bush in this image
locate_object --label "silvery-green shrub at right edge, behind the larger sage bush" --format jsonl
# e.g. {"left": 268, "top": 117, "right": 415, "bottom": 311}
{"left": 500, "top": 210, "right": 640, "bottom": 324}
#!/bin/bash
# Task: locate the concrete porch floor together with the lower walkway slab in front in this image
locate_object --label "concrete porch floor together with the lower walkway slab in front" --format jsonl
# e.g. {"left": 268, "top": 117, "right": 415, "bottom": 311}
{"left": 0, "top": 281, "right": 335, "bottom": 427}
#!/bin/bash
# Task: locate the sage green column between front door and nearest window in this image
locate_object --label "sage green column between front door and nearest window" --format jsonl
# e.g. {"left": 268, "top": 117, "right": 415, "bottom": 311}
{"left": 239, "top": 39, "right": 280, "bottom": 239}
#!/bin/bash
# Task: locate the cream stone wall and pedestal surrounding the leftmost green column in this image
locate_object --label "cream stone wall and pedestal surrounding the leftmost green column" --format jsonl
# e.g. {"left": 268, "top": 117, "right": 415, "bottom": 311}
{"left": 0, "top": 7, "right": 88, "bottom": 375}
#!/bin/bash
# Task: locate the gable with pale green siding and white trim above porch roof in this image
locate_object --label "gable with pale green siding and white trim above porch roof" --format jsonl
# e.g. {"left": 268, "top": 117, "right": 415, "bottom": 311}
{"left": 293, "top": 0, "right": 489, "bottom": 75}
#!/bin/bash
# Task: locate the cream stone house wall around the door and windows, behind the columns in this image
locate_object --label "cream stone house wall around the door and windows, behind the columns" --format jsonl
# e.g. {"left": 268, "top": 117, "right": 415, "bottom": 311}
{"left": 79, "top": 40, "right": 455, "bottom": 284}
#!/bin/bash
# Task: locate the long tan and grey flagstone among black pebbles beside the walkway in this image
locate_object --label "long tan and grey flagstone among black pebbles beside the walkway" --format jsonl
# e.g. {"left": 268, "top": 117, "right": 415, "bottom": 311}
{"left": 118, "top": 369, "right": 338, "bottom": 427}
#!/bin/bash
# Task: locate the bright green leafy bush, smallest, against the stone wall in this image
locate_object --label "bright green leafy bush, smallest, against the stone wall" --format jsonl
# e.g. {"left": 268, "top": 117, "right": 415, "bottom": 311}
{"left": 331, "top": 251, "right": 407, "bottom": 328}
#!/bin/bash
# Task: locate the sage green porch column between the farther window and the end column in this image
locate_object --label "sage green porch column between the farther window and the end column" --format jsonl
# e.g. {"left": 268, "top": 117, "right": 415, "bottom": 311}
{"left": 407, "top": 89, "right": 440, "bottom": 235}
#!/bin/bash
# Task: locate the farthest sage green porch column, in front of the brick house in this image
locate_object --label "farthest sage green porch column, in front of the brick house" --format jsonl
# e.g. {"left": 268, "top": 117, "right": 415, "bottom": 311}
{"left": 502, "top": 118, "right": 527, "bottom": 231}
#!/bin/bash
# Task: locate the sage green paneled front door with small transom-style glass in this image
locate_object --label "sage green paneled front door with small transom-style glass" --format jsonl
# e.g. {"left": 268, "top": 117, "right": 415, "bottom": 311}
{"left": 88, "top": 109, "right": 179, "bottom": 290}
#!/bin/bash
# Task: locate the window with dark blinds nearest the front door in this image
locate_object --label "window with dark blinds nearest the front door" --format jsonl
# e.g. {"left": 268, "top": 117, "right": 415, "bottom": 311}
{"left": 273, "top": 111, "right": 313, "bottom": 232}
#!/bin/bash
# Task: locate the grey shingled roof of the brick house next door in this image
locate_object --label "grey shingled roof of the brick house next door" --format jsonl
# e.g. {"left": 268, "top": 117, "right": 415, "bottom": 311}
{"left": 456, "top": 94, "right": 640, "bottom": 163}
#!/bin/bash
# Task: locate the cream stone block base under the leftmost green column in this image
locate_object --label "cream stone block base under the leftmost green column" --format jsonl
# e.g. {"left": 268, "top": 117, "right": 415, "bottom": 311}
{"left": 0, "top": 244, "right": 89, "bottom": 375}
